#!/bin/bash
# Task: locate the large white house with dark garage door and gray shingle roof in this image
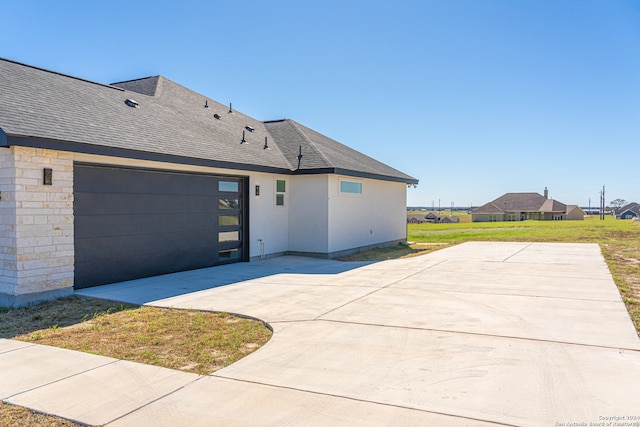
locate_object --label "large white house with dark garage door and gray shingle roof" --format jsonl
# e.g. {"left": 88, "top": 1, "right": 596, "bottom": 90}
{"left": 0, "top": 59, "right": 418, "bottom": 306}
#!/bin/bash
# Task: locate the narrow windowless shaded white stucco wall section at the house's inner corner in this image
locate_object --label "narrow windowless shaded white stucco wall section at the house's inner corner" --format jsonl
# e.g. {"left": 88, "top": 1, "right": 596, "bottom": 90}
{"left": 289, "top": 175, "right": 329, "bottom": 253}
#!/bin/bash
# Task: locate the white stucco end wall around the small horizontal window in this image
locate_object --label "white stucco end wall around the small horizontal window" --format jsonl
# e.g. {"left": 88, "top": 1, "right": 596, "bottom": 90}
{"left": 328, "top": 175, "right": 407, "bottom": 253}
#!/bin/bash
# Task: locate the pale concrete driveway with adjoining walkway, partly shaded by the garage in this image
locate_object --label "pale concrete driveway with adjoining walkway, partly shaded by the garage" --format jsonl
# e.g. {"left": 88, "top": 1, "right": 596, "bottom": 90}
{"left": 0, "top": 243, "right": 640, "bottom": 426}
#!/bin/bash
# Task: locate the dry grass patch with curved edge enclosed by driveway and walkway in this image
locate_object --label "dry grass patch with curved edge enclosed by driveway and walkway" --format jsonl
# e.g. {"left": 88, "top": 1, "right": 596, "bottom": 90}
{"left": 0, "top": 297, "right": 271, "bottom": 375}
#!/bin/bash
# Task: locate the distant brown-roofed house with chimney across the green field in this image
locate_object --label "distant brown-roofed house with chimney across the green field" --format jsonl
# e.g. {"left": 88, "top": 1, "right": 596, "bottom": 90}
{"left": 471, "top": 188, "right": 585, "bottom": 222}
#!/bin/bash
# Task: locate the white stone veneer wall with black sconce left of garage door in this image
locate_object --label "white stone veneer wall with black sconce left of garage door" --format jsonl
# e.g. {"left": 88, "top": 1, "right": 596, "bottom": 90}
{"left": 0, "top": 146, "right": 74, "bottom": 307}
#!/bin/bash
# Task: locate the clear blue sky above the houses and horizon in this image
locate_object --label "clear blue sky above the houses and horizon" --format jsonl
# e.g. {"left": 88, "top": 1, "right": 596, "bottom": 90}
{"left": 0, "top": 0, "right": 640, "bottom": 207}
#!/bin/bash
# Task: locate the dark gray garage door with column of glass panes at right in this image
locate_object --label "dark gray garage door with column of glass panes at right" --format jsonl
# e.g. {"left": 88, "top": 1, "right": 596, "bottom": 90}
{"left": 73, "top": 164, "right": 248, "bottom": 289}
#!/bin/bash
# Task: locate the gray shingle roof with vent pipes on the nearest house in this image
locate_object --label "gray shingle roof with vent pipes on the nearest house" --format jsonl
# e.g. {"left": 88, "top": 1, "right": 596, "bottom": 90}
{"left": 0, "top": 58, "right": 417, "bottom": 183}
